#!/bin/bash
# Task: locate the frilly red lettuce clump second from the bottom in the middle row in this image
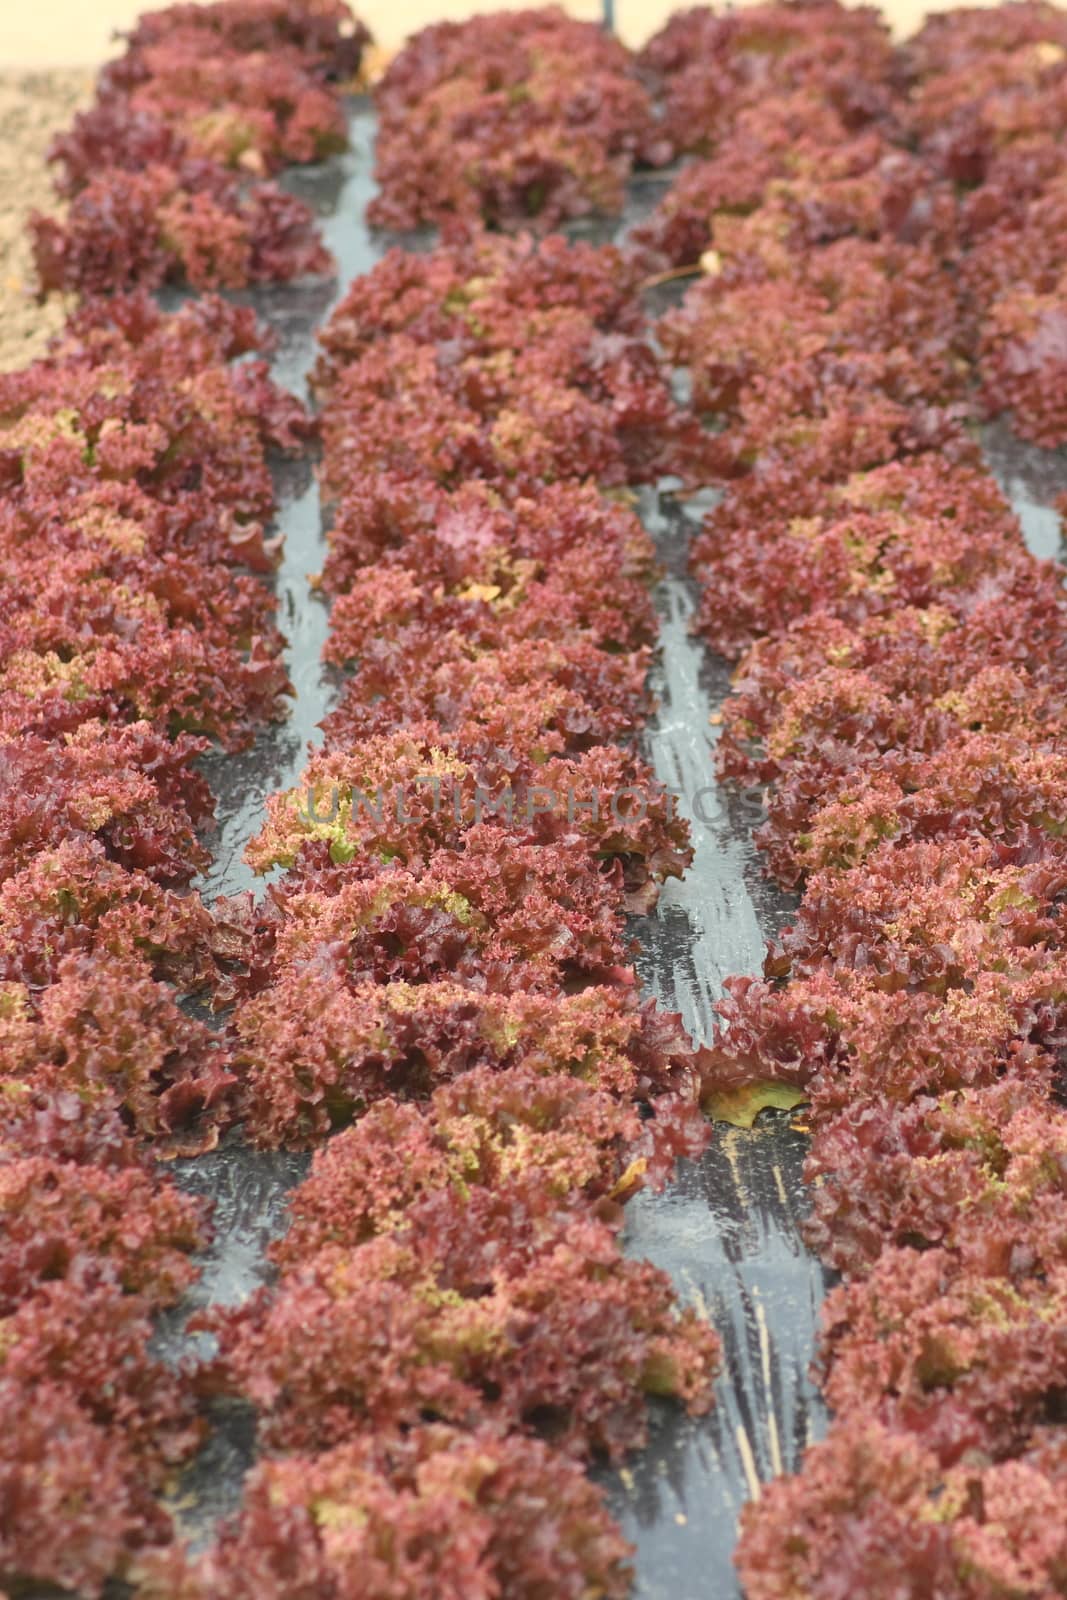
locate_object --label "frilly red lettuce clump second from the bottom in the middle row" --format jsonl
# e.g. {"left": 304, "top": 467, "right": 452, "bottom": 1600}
{"left": 204, "top": 1179, "right": 718, "bottom": 1456}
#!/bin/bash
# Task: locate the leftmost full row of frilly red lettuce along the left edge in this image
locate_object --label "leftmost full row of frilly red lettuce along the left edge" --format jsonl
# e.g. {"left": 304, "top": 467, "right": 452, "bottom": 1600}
{"left": 0, "top": 0, "right": 362, "bottom": 1595}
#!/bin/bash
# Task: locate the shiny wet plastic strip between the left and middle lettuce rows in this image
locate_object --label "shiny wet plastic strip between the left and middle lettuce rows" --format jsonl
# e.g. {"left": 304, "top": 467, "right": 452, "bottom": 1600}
{"left": 158, "top": 101, "right": 389, "bottom": 1546}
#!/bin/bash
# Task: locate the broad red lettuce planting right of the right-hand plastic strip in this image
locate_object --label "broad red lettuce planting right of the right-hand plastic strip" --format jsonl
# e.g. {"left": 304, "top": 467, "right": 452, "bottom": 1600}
{"left": 637, "top": 5, "right": 1067, "bottom": 1600}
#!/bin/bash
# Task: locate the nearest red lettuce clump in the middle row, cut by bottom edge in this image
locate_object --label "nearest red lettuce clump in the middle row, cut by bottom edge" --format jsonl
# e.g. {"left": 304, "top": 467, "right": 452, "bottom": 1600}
{"left": 136, "top": 1422, "right": 630, "bottom": 1600}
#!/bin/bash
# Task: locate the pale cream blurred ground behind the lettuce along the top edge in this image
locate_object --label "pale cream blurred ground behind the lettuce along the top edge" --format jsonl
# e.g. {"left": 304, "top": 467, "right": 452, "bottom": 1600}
{"left": 0, "top": 0, "right": 1017, "bottom": 67}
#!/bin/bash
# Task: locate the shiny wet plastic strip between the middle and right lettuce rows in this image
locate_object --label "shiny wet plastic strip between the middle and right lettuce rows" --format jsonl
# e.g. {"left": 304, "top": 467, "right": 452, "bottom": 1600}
{"left": 603, "top": 493, "right": 825, "bottom": 1600}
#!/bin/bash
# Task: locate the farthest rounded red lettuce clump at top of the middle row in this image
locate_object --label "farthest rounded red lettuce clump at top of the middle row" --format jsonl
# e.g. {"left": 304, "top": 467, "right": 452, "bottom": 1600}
{"left": 368, "top": 8, "right": 670, "bottom": 229}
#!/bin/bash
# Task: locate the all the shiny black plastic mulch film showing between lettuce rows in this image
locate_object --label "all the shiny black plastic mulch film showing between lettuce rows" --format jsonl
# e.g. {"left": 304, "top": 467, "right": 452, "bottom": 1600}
{"left": 147, "top": 99, "right": 1067, "bottom": 1600}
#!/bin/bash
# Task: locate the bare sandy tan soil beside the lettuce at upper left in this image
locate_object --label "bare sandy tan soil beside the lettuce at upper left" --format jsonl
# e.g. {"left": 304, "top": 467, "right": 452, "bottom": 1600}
{"left": 0, "top": 67, "right": 93, "bottom": 373}
